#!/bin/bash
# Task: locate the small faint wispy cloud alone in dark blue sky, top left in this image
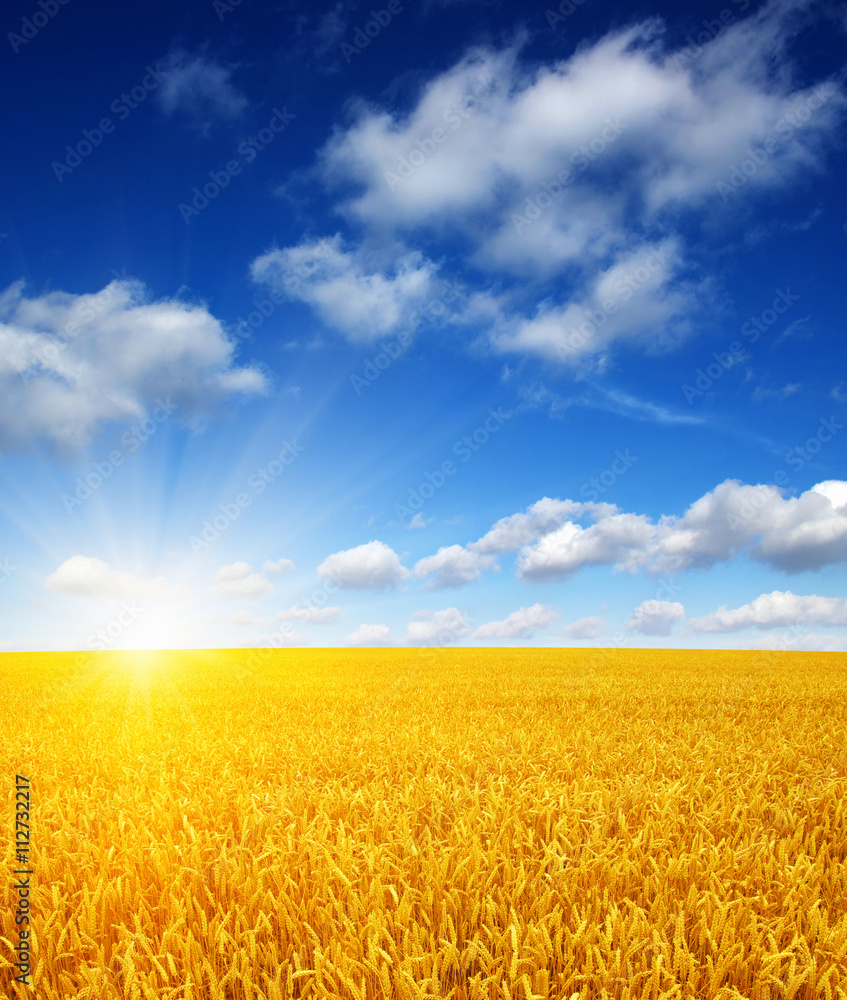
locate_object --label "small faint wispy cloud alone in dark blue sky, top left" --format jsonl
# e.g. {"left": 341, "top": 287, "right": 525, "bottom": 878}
{"left": 157, "top": 51, "right": 247, "bottom": 131}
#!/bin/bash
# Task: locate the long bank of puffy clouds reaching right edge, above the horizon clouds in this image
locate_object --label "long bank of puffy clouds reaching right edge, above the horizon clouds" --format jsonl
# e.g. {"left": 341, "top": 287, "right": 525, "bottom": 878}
{"left": 424, "top": 479, "right": 847, "bottom": 588}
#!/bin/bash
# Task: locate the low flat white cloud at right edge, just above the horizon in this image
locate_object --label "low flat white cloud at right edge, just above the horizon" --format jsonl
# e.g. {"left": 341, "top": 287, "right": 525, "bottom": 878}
{"left": 688, "top": 590, "right": 847, "bottom": 632}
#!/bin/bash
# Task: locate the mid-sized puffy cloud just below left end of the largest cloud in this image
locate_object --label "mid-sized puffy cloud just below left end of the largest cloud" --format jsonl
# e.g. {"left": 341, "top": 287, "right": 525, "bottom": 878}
{"left": 250, "top": 234, "right": 435, "bottom": 343}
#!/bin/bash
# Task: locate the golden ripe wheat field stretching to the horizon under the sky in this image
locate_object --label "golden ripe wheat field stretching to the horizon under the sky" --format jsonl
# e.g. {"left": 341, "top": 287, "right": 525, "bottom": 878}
{"left": 0, "top": 649, "right": 847, "bottom": 1000}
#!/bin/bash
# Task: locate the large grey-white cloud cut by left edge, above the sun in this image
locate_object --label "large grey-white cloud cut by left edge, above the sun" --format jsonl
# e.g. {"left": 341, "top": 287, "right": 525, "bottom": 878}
{"left": 0, "top": 280, "right": 267, "bottom": 449}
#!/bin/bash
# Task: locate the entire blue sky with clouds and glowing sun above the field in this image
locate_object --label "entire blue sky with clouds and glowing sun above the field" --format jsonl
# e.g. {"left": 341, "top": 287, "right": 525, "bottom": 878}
{"left": 0, "top": 0, "right": 847, "bottom": 650}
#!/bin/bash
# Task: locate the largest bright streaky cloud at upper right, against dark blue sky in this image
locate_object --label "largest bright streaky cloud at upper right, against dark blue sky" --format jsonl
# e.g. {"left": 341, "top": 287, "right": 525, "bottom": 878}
{"left": 322, "top": 10, "right": 844, "bottom": 232}
